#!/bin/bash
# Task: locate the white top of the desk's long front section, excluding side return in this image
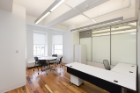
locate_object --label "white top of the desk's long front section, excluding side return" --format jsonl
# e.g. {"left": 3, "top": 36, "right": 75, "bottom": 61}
{"left": 65, "top": 62, "right": 136, "bottom": 90}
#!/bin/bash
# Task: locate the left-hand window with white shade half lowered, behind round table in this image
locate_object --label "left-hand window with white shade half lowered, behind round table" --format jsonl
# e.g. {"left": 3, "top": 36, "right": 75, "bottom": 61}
{"left": 33, "top": 33, "right": 46, "bottom": 56}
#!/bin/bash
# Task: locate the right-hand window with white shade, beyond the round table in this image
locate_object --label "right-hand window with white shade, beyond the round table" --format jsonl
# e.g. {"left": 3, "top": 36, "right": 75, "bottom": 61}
{"left": 53, "top": 35, "right": 63, "bottom": 55}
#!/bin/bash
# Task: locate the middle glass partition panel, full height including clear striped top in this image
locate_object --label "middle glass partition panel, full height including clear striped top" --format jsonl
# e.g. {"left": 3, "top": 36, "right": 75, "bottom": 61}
{"left": 92, "top": 27, "right": 110, "bottom": 63}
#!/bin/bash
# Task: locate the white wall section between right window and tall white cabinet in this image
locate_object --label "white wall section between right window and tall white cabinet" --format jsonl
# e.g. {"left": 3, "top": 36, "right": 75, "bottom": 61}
{"left": 63, "top": 26, "right": 79, "bottom": 63}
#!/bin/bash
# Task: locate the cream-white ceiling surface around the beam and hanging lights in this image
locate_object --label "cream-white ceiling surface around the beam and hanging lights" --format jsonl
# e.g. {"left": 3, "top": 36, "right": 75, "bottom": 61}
{"left": 13, "top": 0, "right": 135, "bottom": 27}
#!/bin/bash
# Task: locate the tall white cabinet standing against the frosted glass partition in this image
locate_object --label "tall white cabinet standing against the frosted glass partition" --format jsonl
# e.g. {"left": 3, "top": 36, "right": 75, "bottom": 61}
{"left": 74, "top": 45, "right": 87, "bottom": 64}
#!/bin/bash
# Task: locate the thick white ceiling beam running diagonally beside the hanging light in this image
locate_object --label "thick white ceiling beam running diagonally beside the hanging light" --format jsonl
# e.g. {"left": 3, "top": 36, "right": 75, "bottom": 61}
{"left": 45, "top": 0, "right": 109, "bottom": 28}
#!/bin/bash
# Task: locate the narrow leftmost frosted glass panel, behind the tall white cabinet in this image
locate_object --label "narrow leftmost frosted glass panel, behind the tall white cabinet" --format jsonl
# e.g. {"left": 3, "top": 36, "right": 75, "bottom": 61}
{"left": 80, "top": 37, "right": 91, "bottom": 61}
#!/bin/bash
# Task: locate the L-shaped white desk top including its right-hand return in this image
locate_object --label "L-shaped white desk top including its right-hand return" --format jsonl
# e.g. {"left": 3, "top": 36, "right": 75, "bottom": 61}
{"left": 66, "top": 62, "right": 137, "bottom": 93}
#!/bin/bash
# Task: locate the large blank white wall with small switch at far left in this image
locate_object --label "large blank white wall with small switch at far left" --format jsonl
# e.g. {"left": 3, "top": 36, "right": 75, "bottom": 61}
{"left": 0, "top": 4, "right": 26, "bottom": 93}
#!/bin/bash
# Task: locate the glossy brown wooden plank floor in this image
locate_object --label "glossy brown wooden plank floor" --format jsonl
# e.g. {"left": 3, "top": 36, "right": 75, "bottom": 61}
{"left": 6, "top": 65, "right": 137, "bottom": 93}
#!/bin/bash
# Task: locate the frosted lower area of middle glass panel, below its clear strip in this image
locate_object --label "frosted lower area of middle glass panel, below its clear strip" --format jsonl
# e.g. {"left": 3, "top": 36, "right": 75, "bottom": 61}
{"left": 92, "top": 35, "right": 110, "bottom": 63}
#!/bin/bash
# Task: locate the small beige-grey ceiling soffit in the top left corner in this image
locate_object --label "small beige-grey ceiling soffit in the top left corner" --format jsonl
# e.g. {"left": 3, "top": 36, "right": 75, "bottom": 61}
{"left": 0, "top": 0, "right": 13, "bottom": 12}
